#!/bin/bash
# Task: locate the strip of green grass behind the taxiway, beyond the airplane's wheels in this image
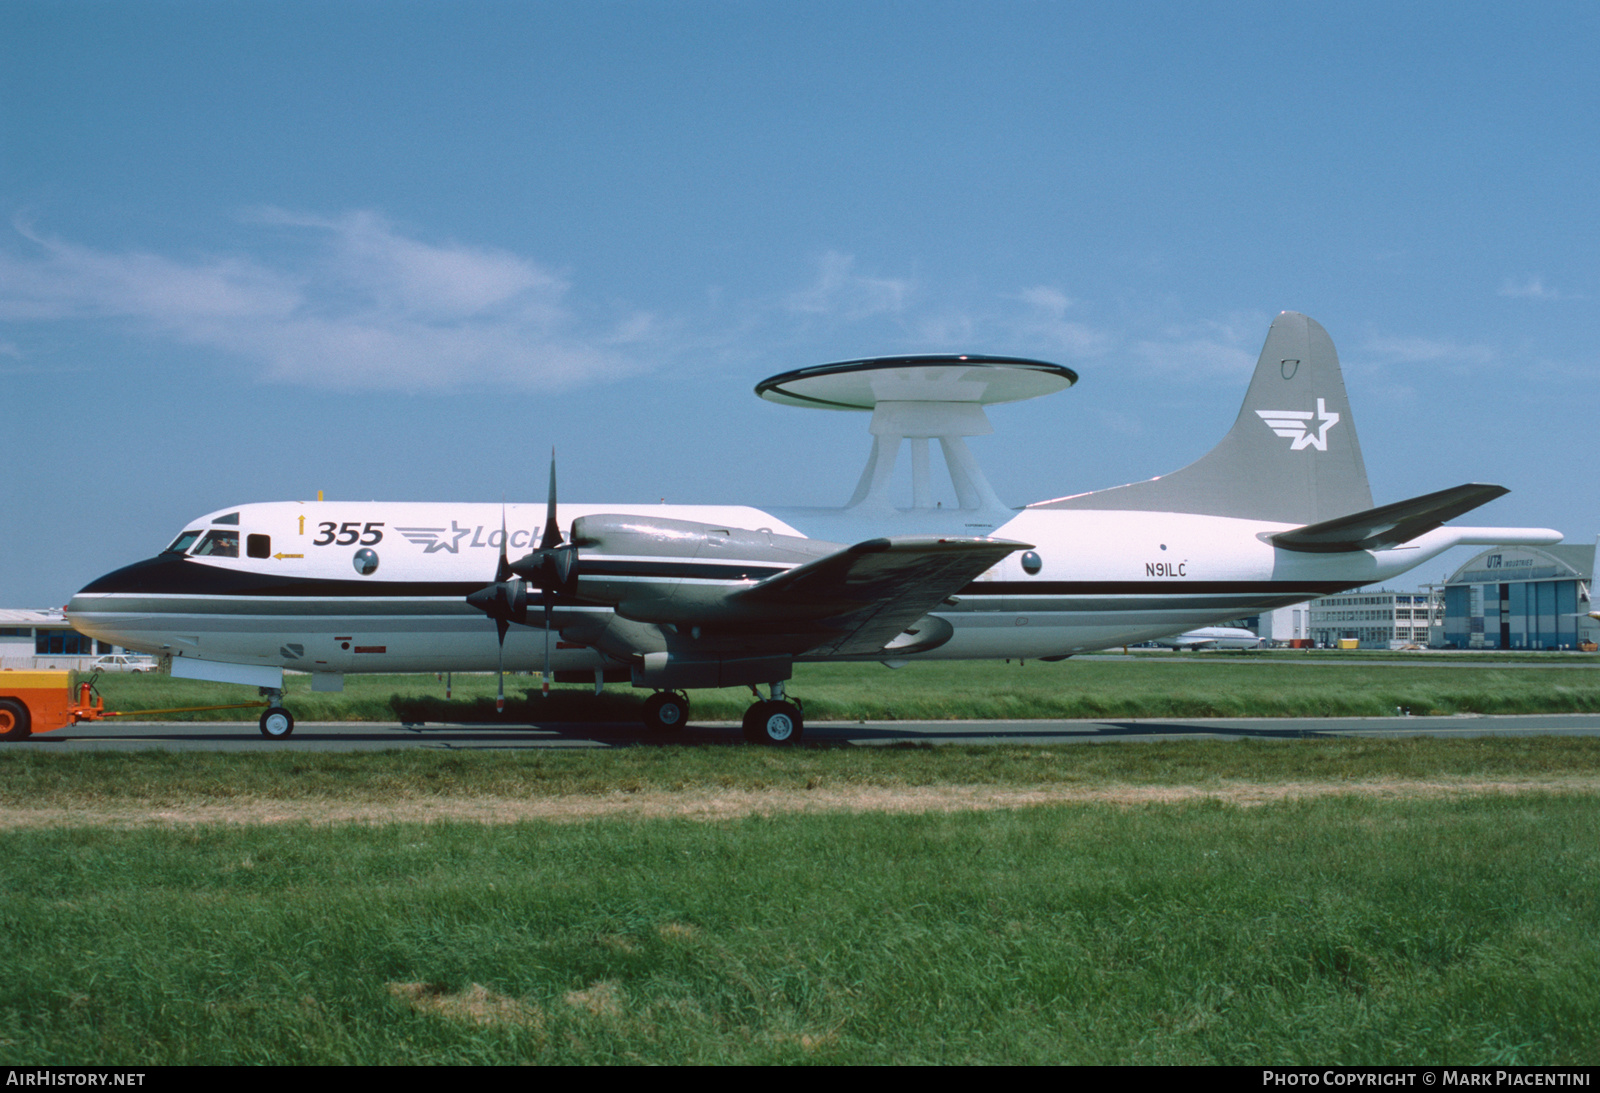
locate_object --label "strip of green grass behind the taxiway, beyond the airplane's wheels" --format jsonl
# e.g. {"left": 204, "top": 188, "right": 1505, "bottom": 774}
{"left": 78, "top": 653, "right": 1600, "bottom": 723}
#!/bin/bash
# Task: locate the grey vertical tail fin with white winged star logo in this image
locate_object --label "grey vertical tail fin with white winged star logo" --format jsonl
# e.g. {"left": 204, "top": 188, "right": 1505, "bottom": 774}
{"left": 1029, "top": 310, "right": 1373, "bottom": 523}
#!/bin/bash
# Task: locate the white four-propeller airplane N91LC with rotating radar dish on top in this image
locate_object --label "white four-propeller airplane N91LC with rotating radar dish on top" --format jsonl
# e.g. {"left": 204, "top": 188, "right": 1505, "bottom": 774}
{"left": 67, "top": 312, "right": 1562, "bottom": 744}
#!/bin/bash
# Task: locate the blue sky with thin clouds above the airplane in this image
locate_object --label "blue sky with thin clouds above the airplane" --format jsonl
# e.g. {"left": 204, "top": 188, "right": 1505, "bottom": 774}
{"left": 0, "top": 0, "right": 1600, "bottom": 607}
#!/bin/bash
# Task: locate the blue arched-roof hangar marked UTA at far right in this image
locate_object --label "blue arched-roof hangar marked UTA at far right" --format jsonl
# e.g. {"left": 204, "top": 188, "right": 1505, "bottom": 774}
{"left": 1440, "top": 542, "right": 1600, "bottom": 650}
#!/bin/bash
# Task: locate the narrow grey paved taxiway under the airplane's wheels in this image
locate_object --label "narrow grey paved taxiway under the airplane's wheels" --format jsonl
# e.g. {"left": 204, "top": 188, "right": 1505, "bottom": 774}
{"left": 13, "top": 714, "right": 1600, "bottom": 752}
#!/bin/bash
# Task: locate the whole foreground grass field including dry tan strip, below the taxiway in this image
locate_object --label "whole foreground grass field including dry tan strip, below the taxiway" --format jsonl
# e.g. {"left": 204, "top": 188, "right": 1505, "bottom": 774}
{"left": 0, "top": 738, "right": 1600, "bottom": 1066}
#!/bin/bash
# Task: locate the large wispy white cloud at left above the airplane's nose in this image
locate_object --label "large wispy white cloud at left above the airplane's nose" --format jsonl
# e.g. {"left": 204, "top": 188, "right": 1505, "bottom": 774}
{"left": 0, "top": 210, "right": 654, "bottom": 390}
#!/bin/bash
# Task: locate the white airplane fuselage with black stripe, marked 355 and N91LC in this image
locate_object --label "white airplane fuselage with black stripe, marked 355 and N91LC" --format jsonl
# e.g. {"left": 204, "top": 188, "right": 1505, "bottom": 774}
{"left": 69, "top": 501, "right": 1456, "bottom": 672}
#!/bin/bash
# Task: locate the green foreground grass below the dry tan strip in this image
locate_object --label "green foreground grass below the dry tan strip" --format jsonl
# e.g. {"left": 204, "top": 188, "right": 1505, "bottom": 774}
{"left": 0, "top": 795, "right": 1600, "bottom": 1066}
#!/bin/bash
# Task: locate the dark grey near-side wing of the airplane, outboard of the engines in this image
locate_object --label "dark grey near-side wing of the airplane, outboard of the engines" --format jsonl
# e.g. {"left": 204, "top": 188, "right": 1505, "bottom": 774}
{"left": 730, "top": 536, "right": 1030, "bottom": 656}
